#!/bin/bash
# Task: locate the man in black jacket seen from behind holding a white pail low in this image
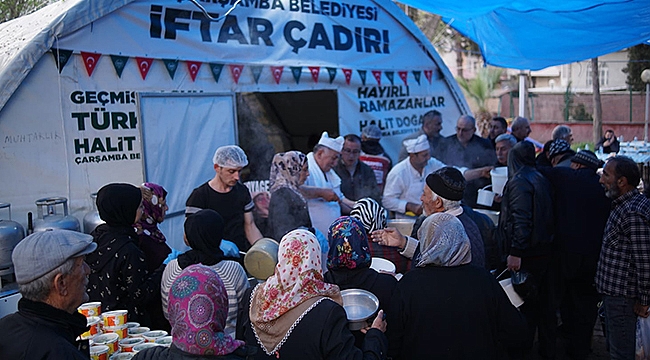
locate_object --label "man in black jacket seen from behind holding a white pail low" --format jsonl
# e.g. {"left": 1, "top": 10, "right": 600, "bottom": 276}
{"left": 497, "top": 141, "right": 555, "bottom": 359}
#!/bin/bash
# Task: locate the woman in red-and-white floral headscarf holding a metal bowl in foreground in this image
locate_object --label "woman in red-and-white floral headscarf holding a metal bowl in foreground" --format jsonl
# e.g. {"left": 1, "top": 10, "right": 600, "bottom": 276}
{"left": 237, "top": 230, "right": 387, "bottom": 359}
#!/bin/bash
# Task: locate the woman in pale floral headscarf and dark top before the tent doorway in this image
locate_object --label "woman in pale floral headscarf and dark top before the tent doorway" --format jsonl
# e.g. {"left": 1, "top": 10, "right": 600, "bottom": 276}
{"left": 269, "top": 151, "right": 311, "bottom": 240}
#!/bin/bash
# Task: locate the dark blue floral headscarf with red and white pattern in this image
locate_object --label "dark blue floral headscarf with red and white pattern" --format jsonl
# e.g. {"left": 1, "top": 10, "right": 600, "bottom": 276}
{"left": 327, "top": 216, "right": 371, "bottom": 270}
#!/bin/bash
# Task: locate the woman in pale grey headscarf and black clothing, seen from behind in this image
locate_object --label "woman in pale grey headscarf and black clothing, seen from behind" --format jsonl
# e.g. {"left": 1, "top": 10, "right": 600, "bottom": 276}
{"left": 387, "top": 213, "right": 526, "bottom": 359}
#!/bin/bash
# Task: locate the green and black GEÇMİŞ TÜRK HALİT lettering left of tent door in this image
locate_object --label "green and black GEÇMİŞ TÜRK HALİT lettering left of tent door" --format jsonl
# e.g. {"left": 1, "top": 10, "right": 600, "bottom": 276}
{"left": 70, "top": 91, "right": 140, "bottom": 165}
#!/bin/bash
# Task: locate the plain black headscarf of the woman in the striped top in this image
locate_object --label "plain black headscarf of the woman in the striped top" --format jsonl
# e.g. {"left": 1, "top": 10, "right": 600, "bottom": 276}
{"left": 178, "top": 209, "right": 224, "bottom": 269}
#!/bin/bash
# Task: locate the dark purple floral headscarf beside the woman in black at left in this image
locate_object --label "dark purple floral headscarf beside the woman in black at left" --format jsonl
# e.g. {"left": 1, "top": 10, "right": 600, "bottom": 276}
{"left": 135, "top": 183, "right": 167, "bottom": 243}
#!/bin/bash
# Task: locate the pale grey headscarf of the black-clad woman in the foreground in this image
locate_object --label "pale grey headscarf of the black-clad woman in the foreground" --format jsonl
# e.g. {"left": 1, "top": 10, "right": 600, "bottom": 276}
{"left": 415, "top": 213, "right": 472, "bottom": 267}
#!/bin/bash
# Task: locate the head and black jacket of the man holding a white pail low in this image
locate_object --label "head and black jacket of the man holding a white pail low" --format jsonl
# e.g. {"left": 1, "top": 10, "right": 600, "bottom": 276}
{"left": 497, "top": 141, "right": 554, "bottom": 258}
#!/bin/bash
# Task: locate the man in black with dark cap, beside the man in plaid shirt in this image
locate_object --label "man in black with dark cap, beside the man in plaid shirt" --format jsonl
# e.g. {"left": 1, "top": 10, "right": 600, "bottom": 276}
{"left": 539, "top": 149, "right": 611, "bottom": 359}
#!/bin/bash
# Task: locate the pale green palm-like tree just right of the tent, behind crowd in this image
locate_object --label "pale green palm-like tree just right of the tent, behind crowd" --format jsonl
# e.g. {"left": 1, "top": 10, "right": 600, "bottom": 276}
{"left": 456, "top": 66, "right": 503, "bottom": 136}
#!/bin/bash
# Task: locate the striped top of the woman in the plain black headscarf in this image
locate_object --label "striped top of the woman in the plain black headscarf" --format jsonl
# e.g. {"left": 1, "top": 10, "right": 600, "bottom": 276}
{"left": 160, "top": 259, "right": 249, "bottom": 338}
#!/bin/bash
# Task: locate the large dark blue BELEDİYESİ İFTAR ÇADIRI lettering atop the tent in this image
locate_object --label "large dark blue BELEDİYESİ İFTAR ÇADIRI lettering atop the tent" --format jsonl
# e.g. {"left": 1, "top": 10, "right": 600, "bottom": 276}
{"left": 149, "top": 4, "right": 390, "bottom": 54}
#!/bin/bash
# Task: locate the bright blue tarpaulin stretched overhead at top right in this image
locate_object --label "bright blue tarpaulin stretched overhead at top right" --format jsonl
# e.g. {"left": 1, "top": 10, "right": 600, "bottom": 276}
{"left": 400, "top": 0, "right": 650, "bottom": 70}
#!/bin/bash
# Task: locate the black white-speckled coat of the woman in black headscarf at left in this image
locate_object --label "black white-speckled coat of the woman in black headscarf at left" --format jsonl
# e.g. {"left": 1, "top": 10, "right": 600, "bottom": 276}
{"left": 86, "top": 224, "right": 164, "bottom": 326}
